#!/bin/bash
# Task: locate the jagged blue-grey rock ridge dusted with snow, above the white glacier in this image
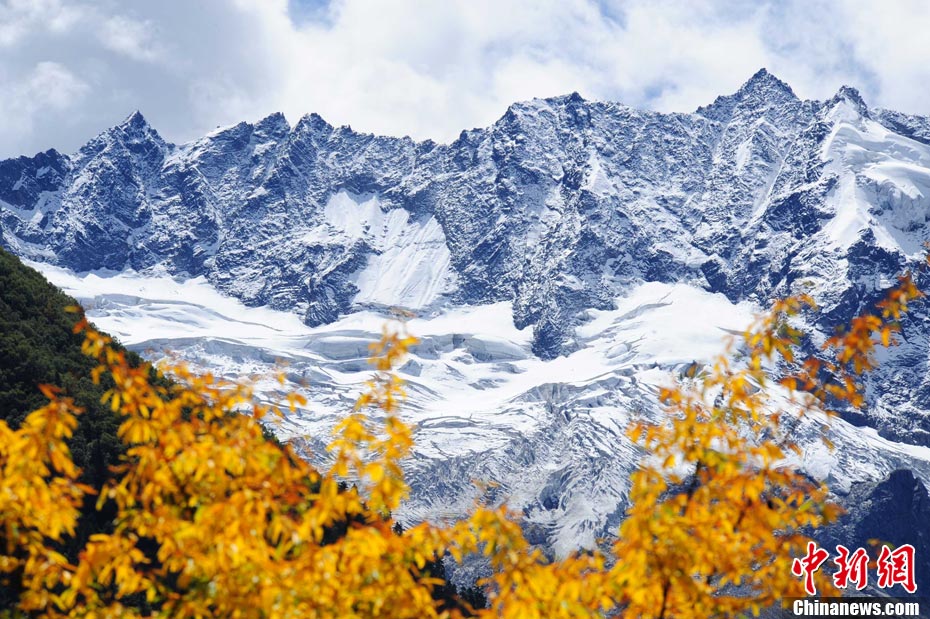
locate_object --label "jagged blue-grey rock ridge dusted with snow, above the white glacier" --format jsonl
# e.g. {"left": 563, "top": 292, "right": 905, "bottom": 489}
{"left": 0, "top": 70, "right": 930, "bottom": 445}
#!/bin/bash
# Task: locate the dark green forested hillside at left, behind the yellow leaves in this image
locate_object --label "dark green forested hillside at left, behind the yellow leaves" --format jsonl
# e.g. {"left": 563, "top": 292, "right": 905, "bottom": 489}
{"left": 0, "top": 248, "right": 486, "bottom": 610}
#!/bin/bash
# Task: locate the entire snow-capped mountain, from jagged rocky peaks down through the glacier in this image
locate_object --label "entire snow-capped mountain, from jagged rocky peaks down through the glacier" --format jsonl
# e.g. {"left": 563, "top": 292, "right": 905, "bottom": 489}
{"left": 0, "top": 70, "right": 930, "bottom": 568}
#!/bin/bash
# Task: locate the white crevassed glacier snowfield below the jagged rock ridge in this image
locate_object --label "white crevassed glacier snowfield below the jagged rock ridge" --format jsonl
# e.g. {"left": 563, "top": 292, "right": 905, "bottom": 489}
{"left": 31, "top": 263, "right": 930, "bottom": 553}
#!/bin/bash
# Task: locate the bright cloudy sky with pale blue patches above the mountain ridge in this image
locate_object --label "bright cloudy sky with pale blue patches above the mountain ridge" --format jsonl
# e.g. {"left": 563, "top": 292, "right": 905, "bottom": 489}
{"left": 0, "top": 0, "right": 930, "bottom": 157}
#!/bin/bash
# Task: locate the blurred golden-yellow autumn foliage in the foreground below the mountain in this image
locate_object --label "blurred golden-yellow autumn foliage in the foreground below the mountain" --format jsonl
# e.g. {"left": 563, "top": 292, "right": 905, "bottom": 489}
{"left": 0, "top": 254, "right": 920, "bottom": 619}
